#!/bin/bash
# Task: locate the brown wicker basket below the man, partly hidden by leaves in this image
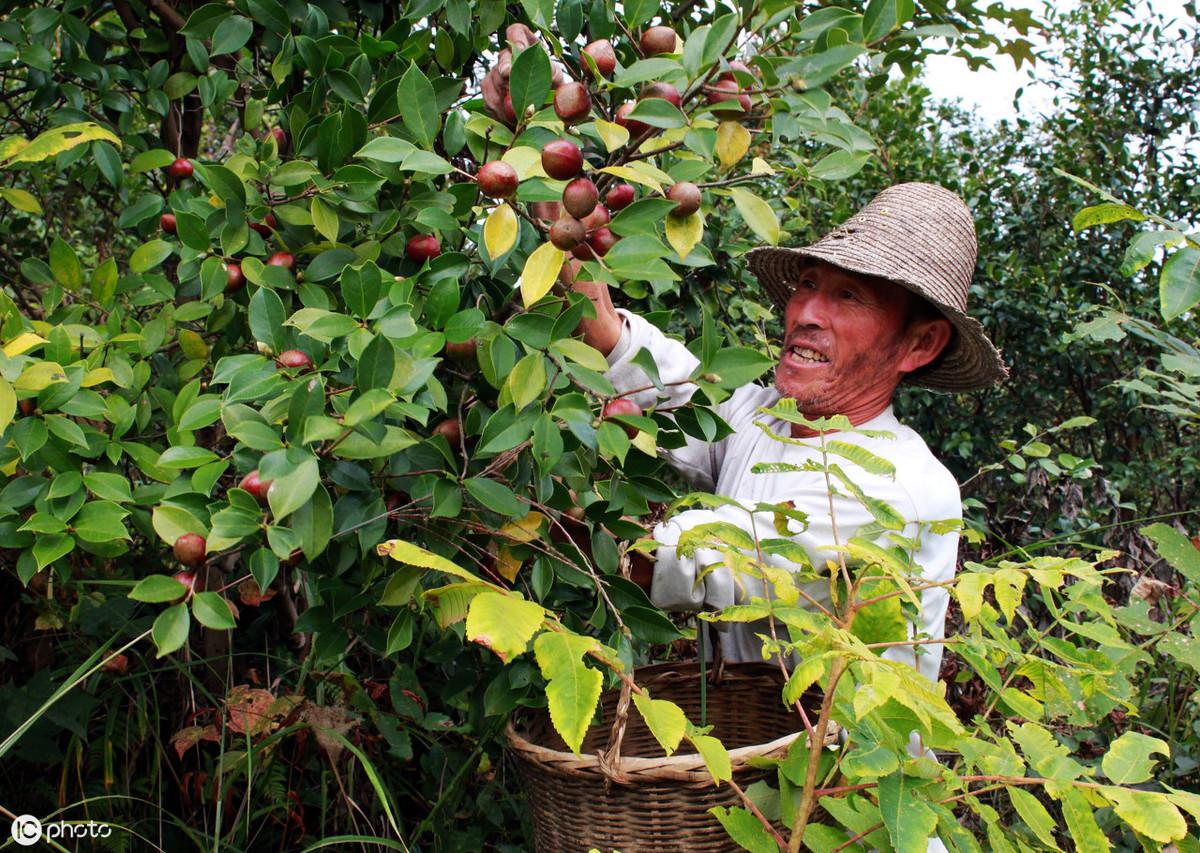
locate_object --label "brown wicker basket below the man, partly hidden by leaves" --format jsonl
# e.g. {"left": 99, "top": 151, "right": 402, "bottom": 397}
{"left": 506, "top": 663, "right": 838, "bottom": 853}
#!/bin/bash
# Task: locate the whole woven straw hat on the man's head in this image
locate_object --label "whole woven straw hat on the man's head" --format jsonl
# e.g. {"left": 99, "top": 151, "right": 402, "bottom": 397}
{"left": 746, "top": 184, "right": 1008, "bottom": 391}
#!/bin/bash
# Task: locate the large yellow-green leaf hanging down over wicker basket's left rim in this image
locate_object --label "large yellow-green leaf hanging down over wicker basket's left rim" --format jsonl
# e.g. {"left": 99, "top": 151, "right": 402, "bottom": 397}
{"left": 533, "top": 631, "right": 604, "bottom": 755}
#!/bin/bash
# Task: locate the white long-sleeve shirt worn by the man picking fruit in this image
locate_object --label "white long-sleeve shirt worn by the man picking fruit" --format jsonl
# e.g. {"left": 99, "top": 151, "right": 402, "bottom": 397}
{"left": 607, "top": 311, "right": 962, "bottom": 681}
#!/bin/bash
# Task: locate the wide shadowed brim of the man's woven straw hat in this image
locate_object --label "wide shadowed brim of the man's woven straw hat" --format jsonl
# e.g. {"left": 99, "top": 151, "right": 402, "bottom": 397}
{"left": 746, "top": 242, "right": 1008, "bottom": 394}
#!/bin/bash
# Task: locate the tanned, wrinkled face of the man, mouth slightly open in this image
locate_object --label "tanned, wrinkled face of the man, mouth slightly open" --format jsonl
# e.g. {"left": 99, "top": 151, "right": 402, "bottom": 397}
{"left": 775, "top": 262, "right": 950, "bottom": 424}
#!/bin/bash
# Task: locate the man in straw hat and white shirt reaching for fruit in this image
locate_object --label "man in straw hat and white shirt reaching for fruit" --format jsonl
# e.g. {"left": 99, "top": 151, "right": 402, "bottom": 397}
{"left": 574, "top": 184, "right": 1007, "bottom": 681}
